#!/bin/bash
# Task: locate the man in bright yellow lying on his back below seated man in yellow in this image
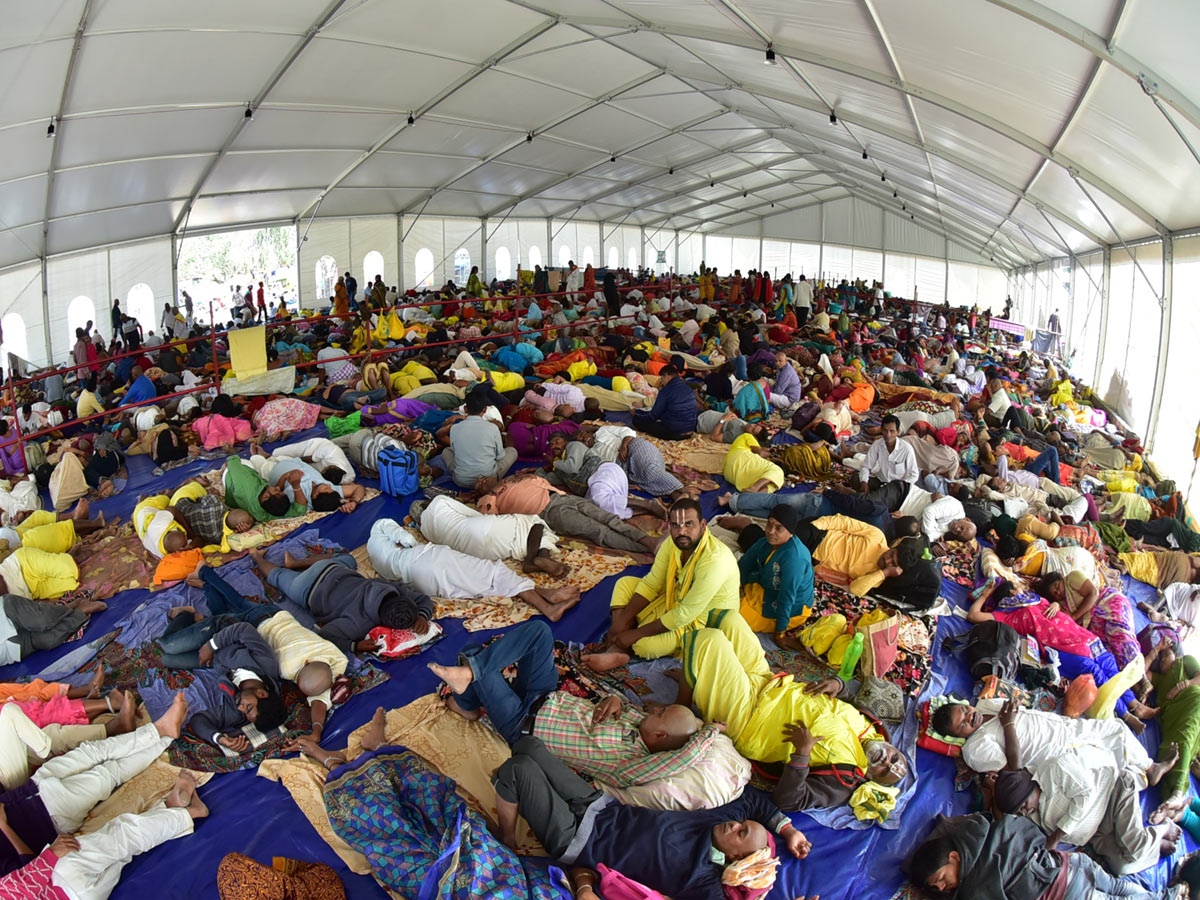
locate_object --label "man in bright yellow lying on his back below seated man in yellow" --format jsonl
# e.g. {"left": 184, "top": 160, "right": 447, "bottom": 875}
{"left": 677, "top": 611, "right": 908, "bottom": 812}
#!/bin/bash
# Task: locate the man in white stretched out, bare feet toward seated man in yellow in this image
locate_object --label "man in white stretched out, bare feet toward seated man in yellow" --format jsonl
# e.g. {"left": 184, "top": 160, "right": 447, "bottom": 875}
{"left": 367, "top": 511, "right": 580, "bottom": 622}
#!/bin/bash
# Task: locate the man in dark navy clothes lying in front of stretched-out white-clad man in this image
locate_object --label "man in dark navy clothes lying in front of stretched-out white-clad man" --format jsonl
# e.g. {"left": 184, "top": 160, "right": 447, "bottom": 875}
{"left": 250, "top": 550, "right": 433, "bottom": 653}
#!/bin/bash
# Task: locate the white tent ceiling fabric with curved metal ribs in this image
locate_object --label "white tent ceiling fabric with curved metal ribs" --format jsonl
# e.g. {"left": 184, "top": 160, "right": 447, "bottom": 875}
{"left": 0, "top": 0, "right": 1200, "bottom": 268}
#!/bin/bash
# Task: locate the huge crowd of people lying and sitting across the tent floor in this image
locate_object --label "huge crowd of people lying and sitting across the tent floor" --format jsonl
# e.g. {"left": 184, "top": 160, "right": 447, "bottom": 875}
{"left": 0, "top": 263, "right": 1200, "bottom": 900}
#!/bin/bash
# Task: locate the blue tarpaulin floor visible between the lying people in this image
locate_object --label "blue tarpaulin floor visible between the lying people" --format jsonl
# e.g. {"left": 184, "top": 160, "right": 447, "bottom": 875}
{"left": 0, "top": 432, "right": 1190, "bottom": 900}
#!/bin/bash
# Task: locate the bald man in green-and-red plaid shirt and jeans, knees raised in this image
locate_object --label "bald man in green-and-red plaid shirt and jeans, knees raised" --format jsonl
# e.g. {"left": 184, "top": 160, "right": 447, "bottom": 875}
{"left": 430, "top": 622, "right": 715, "bottom": 787}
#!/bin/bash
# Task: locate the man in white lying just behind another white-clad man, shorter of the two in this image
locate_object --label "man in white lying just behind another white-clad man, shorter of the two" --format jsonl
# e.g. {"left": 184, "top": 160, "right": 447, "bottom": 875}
{"left": 412, "top": 494, "right": 569, "bottom": 578}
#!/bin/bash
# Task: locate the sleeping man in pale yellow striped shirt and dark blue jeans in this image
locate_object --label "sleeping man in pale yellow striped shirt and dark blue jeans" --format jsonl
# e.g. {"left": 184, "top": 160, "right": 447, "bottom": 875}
{"left": 158, "top": 562, "right": 348, "bottom": 740}
